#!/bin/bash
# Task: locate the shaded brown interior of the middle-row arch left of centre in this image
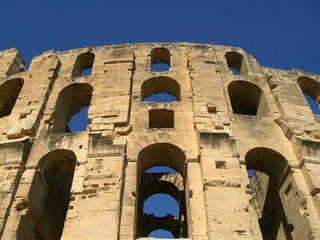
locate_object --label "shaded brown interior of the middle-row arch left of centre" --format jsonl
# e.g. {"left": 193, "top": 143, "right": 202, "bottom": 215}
{"left": 51, "top": 83, "right": 93, "bottom": 133}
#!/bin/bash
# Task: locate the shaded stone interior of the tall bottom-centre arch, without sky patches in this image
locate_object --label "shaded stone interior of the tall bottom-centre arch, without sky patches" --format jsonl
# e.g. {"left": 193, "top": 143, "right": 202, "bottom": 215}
{"left": 137, "top": 143, "right": 188, "bottom": 238}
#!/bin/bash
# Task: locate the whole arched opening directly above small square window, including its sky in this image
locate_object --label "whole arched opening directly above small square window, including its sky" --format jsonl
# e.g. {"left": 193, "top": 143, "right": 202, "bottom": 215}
{"left": 141, "top": 76, "right": 180, "bottom": 102}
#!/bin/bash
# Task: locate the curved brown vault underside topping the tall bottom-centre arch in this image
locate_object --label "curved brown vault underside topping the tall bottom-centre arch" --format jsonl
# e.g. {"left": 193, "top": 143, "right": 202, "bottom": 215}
{"left": 138, "top": 143, "right": 186, "bottom": 177}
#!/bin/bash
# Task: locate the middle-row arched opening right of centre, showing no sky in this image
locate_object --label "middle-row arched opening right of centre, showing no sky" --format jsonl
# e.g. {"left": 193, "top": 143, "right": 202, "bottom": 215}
{"left": 228, "top": 81, "right": 269, "bottom": 116}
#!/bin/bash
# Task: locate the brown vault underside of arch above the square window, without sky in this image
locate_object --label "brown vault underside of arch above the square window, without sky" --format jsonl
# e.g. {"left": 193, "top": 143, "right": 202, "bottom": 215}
{"left": 141, "top": 76, "right": 180, "bottom": 102}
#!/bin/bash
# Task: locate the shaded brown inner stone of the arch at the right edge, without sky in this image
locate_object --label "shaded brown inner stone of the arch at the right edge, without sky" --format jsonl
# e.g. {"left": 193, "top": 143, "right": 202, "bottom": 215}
{"left": 297, "top": 77, "right": 320, "bottom": 110}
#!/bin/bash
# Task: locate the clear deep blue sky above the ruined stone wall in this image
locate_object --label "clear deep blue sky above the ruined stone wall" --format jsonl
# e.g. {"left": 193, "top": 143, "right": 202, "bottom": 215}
{"left": 0, "top": 0, "right": 320, "bottom": 238}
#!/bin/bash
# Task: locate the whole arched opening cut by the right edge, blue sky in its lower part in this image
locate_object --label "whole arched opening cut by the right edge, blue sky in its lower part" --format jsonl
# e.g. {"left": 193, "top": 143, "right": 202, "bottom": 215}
{"left": 297, "top": 77, "right": 320, "bottom": 114}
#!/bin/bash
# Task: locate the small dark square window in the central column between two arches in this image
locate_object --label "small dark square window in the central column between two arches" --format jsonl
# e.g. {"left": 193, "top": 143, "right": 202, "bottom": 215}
{"left": 149, "top": 109, "right": 174, "bottom": 128}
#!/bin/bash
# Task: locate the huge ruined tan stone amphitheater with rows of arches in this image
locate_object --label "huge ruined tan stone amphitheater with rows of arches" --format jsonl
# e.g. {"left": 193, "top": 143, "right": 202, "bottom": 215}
{"left": 0, "top": 42, "right": 320, "bottom": 240}
